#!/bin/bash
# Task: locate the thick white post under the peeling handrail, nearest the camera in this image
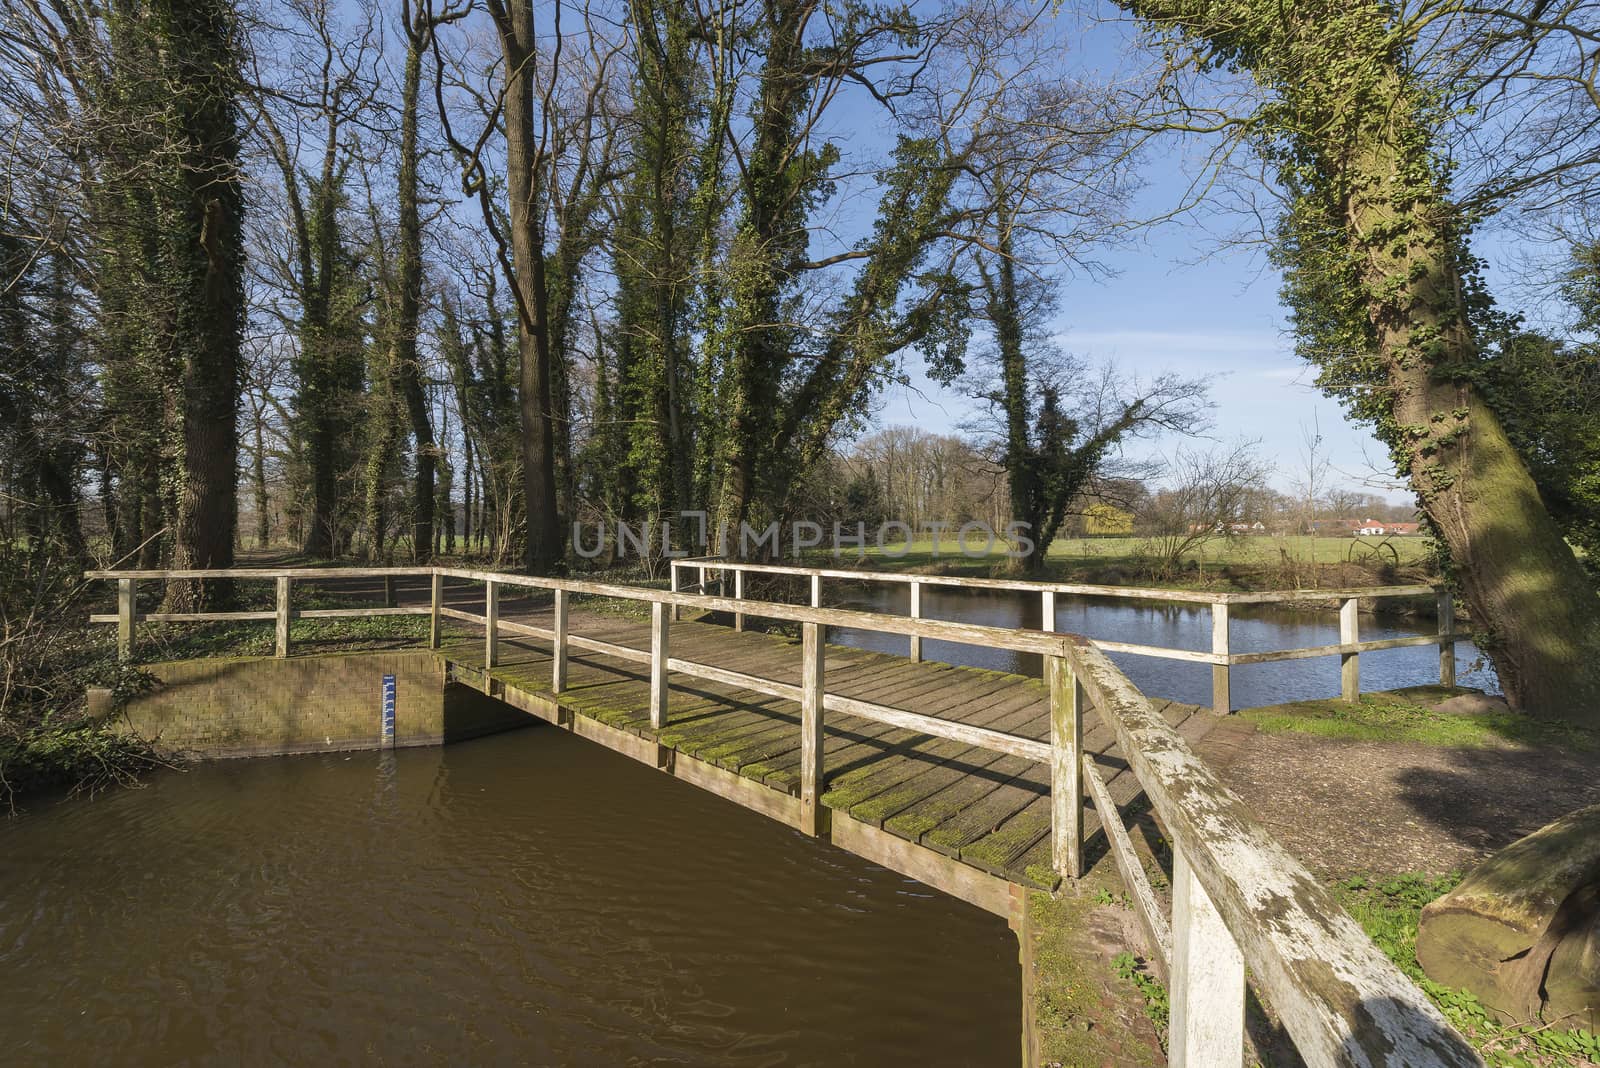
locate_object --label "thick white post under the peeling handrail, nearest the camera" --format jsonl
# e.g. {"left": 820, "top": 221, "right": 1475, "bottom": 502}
{"left": 1166, "top": 846, "right": 1245, "bottom": 1068}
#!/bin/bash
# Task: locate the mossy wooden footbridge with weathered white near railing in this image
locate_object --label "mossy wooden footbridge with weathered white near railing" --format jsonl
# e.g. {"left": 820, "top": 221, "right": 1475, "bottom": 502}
{"left": 90, "top": 561, "right": 1480, "bottom": 1066}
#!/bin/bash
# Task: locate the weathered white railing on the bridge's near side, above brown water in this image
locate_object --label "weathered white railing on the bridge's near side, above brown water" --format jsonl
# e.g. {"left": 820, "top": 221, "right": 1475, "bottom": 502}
{"left": 88, "top": 564, "right": 1482, "bottom": 1068}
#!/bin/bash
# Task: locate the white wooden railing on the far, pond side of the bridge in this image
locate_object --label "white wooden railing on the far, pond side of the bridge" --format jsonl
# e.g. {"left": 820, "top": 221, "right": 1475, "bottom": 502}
{"left": 670, "top": 556, "right": 1469, "bottom": 713}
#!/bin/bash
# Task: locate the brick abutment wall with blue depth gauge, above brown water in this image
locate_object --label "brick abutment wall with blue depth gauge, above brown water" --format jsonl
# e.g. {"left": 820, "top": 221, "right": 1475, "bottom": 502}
{"left": 90, "top": 652, "right": 533, "bottom": 756}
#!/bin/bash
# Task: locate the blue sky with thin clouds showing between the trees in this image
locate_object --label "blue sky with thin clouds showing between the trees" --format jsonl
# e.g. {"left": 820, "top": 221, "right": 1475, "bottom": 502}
{"left": 856, "top": 8, "right": 1411, "bottom": 502}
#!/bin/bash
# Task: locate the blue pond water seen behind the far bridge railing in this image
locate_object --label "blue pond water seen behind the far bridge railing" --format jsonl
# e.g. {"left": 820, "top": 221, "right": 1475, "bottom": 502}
{"left": 824, "top": 582, "right": 1499, "bottom": 708}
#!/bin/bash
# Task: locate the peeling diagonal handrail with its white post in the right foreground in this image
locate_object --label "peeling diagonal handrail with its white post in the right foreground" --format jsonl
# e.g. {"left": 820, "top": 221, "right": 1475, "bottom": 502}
{"left": 1066, "top": 636, "right": 1482, "bottom": 1068}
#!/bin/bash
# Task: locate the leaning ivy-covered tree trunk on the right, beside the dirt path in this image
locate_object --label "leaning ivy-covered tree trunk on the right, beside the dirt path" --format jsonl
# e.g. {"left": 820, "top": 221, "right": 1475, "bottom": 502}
{"left": 1128, "top": 0, "right": 1600, "bottom": 726}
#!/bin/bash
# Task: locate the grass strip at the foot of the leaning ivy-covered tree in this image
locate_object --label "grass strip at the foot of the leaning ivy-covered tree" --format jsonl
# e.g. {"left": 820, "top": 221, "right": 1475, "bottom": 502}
{"left": 1238, "top": 686, "right": 1600, "bottom": 751}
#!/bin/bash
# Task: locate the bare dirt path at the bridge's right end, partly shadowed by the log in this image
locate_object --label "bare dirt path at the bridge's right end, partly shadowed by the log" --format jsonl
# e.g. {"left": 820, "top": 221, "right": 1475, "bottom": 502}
{"left": 1197, "top": 718, "right": 1600, "bottom": 876}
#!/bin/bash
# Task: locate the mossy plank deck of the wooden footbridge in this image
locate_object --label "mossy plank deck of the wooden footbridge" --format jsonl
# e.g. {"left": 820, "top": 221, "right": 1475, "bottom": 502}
{"left": 443, "top": 598, "right": 1216, "bottom": 889}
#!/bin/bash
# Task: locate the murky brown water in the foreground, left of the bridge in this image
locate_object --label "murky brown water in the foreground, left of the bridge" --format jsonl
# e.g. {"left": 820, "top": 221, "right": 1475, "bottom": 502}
{"left": 0, "top": 727, "right": 1021, "bottom": 1066}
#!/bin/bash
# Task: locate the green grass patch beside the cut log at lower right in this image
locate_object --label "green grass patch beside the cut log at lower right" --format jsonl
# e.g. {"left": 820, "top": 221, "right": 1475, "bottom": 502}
{"left": 1333, "top": 873, "right": 1600, "bottom": 1068}
